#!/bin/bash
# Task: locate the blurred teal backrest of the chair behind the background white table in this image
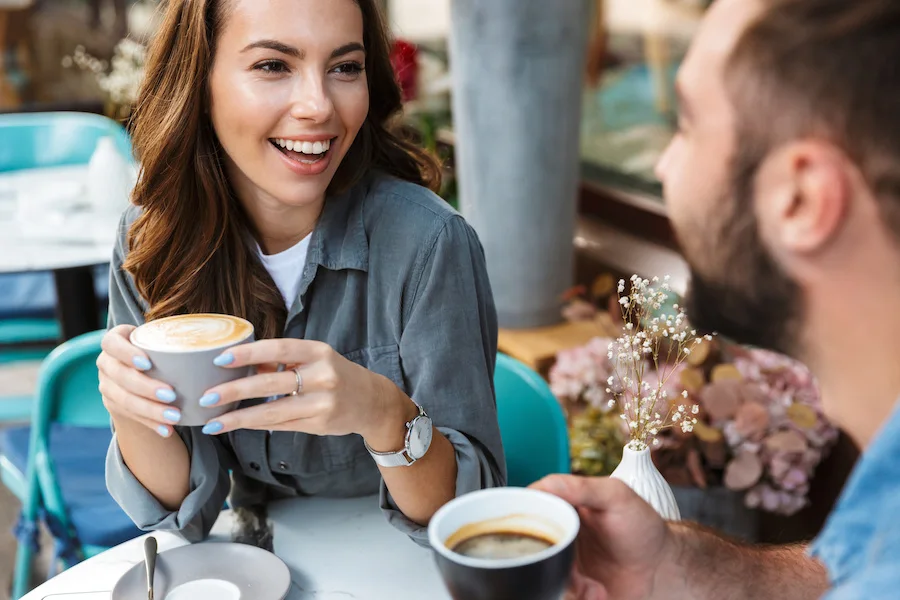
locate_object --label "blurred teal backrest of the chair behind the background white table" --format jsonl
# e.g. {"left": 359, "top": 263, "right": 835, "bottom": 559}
{"left": 0, "top": 112, "right": 133, "bottom": 173}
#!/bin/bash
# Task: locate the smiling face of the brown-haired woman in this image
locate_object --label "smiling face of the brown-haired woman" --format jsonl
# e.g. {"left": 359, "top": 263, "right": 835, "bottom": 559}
{"left": 209, "top": 0, "right": 369, "bottom": 207}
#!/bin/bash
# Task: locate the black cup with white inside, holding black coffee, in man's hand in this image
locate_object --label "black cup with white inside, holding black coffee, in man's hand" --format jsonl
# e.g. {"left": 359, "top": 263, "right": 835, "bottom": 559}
{"left": 428, "top": 488, "right": 579, "bottom": 600}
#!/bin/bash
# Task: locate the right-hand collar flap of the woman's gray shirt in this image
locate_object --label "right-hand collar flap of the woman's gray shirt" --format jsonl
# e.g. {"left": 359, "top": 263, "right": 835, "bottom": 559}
{"left": 308, "top": 177, "right": 371, "bottom": 271}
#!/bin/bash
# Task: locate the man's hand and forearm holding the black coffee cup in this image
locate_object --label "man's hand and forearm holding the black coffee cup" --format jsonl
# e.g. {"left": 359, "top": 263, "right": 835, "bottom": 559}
{"left": 534, "top": 475, "right": 828, "bottom": 600}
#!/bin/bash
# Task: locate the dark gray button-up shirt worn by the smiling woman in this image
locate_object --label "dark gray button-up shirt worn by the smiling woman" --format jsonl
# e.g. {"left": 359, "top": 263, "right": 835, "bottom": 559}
{"left": 106, "top": 174, "right": 506, "bottom": 544}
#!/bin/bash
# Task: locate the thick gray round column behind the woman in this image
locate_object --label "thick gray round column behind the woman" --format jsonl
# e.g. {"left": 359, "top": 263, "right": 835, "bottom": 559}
{"left": 450, "top": 0, "right": 590, "bottom": 328}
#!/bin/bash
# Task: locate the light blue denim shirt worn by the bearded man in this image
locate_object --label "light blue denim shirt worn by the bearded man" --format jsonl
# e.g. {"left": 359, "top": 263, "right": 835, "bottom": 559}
{"left": 811, "top": 402, "right": 900, "bottom": 600}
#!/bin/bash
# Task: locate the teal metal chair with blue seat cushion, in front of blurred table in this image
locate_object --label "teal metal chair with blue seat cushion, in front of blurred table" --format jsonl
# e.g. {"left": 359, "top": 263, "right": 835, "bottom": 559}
{"left": 0, "top": 331, "right": 141, "bottom": 599}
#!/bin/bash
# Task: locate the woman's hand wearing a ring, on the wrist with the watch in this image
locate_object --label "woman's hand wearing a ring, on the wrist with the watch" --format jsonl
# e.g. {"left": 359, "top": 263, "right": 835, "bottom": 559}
{"left": 201, "top": 338, "right": 417, "bottom": 451}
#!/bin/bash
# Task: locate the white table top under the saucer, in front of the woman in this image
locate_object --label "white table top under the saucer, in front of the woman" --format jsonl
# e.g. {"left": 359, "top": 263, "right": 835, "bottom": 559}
{"left": 23, "top": 497, "right": 449, "bottom": 600}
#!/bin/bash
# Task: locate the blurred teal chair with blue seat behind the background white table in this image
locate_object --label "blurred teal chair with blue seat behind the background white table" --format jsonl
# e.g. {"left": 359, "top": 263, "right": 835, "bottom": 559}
{"left": 0, "top": 112, "right": 133, "bottom": 354}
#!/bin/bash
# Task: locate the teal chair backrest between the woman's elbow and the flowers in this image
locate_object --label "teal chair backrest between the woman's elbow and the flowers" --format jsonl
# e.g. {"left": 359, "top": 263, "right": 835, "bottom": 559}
{"left": 494, "top": 353, "right": 570, "bottom": 486}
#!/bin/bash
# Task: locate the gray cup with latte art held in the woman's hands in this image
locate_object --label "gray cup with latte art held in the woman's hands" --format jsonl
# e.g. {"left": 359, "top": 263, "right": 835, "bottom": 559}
{"left": 131, "top": 314, "right": 254, "bottom": 426}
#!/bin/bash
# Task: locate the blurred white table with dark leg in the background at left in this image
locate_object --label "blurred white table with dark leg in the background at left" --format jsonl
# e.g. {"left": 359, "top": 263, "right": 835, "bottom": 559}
{"left": 0, "top": 165, "right": 121, "bottom": 340}
